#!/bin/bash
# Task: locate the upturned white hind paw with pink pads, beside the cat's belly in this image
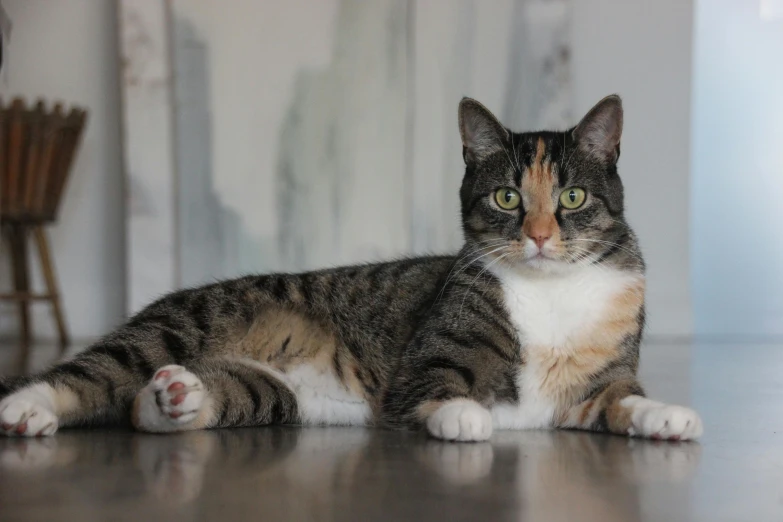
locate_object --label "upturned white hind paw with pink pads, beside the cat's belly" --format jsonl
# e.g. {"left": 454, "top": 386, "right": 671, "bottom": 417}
{"left": 134, "top": 364, "right": 205, "bottom": 432}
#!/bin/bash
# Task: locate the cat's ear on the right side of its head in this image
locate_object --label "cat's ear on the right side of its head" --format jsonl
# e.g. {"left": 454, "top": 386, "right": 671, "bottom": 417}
{"left": 573, "top": 94, "right": 623, "bottom": 164}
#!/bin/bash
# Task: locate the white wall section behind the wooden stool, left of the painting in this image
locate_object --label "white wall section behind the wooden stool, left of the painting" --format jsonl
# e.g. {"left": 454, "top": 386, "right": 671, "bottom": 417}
{"left": 0, "top": 0, "right": 125, "bottom": 338}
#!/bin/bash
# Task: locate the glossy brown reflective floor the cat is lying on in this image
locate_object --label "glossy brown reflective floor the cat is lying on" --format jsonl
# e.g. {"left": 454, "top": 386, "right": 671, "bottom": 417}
{"left": 0, "top": 345, "right": 783, "bottom": 522}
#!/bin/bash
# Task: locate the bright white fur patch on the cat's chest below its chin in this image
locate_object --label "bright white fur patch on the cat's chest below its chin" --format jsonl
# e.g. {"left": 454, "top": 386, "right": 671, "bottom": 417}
{"left": 496, "top": 267, "right": 639, "bottom": 350}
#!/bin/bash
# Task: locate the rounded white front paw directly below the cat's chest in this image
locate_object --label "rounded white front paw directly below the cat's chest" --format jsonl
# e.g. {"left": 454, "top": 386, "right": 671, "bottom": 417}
{"left": 427, "top": 399, "right": 492, "bottom": 442}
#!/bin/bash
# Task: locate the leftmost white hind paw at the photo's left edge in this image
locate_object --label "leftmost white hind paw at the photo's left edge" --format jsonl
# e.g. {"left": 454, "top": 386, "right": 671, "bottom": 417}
{"left": 0, "top": 384, "right": 57, "bottom": 437}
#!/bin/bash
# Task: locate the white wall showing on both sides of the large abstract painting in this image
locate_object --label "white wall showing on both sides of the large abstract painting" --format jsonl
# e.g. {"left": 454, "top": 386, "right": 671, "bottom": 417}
{"left": 0, "top": 0, "right": 700, "bottom": 337}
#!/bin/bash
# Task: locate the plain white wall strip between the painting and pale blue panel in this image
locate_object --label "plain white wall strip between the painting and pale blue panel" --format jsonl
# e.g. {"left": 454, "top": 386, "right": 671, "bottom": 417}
{"left": 573, "top": 0, "right": 696, "bottom": 336}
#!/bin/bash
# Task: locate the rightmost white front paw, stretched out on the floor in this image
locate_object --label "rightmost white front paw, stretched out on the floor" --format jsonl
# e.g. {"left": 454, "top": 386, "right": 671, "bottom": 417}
{"left": 620, "top": 395, "right": 704, "bottom": 440}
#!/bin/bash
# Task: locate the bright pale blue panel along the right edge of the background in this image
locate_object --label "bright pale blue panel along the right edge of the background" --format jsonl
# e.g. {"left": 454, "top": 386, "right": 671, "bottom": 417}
{"left": 691, "top": 0, "right": 783, "bottom": 338}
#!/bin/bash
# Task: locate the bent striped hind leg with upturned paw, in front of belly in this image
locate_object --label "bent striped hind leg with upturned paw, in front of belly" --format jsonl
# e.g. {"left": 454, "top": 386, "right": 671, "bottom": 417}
{"left": 131, "top": 357, "right": 299, "bottom": 433}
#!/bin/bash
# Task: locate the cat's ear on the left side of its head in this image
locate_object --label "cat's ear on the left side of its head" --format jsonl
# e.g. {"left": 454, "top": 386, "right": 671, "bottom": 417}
{"left": 459, "top": 98, "right": 508, "bottom": 164}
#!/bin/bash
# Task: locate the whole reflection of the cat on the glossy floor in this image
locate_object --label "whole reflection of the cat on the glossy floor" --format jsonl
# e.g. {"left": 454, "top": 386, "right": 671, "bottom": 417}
{"left": 0, "top": 428, "right": 701, "bottom": 521}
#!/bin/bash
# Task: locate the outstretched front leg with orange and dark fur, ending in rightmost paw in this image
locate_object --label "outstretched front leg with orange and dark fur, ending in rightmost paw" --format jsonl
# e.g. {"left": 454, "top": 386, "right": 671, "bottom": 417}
{"left": 559, "top": 379, "right": 704, "bottom": 440}
